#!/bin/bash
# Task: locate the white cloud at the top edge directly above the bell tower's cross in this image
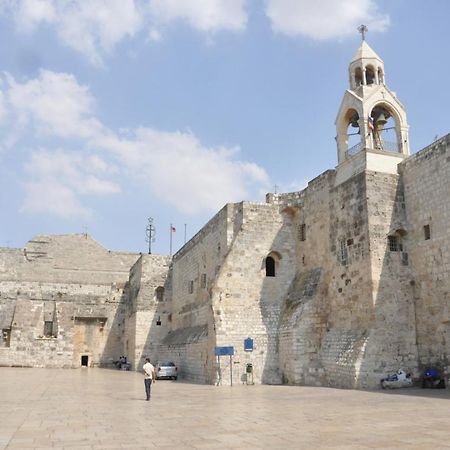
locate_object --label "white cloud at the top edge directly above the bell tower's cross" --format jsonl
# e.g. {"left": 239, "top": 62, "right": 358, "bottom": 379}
{"left": 266, "top": 0, "right": 389, "bottom": 40}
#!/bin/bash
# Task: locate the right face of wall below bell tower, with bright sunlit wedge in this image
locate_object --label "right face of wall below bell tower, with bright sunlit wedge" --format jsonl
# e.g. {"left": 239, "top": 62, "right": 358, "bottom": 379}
{"left": 361, "top": 172, "right": 418, "bottom": 387}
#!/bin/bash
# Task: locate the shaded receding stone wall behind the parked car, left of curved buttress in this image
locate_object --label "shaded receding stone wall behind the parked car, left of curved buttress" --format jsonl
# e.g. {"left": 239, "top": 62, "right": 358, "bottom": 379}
{"left": 157, "top": 204, "right": 239, "bottom": 383}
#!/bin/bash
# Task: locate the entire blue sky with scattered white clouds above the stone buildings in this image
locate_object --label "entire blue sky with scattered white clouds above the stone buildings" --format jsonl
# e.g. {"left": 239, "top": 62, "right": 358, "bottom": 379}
{"left": 0, "top": 0, "right": 450, "bottom": 254}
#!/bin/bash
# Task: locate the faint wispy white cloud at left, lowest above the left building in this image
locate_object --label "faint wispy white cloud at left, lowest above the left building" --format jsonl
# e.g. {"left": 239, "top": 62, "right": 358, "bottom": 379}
{"left": 22, "top": 149, "right": 120, "bottom": 218}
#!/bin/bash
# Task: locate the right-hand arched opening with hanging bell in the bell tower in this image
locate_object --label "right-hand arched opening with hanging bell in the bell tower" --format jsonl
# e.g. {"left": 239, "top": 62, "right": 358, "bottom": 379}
{"left": 369, "top": 104, "right": 401, "bottom": 153}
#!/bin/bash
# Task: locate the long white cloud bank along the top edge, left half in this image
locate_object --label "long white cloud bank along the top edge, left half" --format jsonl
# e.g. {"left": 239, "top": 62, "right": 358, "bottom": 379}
{"left": 0, "top": 0, "right": 247, "bottom": 66}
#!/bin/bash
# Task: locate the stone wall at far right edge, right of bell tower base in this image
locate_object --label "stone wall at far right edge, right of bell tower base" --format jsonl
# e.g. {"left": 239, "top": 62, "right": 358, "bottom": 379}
{"left": 400, "top": 135, "right": 450, "bottom": 374}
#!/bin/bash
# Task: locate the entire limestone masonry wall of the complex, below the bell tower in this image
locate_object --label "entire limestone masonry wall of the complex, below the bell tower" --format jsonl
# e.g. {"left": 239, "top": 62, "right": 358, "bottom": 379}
{"left": 0, "top": 136, "right": 450, "bottom": 388}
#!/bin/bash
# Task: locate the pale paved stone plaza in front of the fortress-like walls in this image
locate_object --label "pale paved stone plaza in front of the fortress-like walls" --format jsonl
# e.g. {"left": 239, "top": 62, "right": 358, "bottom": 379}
{"left": 0, "top": 368, "right": 450, "bottom": 450}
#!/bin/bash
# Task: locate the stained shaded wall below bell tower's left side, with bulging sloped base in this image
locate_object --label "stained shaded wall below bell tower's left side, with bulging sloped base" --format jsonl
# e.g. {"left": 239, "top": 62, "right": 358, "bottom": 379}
{"left": 279, "top": 171, "right": 378, "bottom": 387}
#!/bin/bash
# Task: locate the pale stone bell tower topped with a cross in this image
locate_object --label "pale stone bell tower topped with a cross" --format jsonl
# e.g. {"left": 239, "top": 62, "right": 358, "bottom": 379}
{"left": 335, "top": 25, "right": 409, "bottom": 184}
